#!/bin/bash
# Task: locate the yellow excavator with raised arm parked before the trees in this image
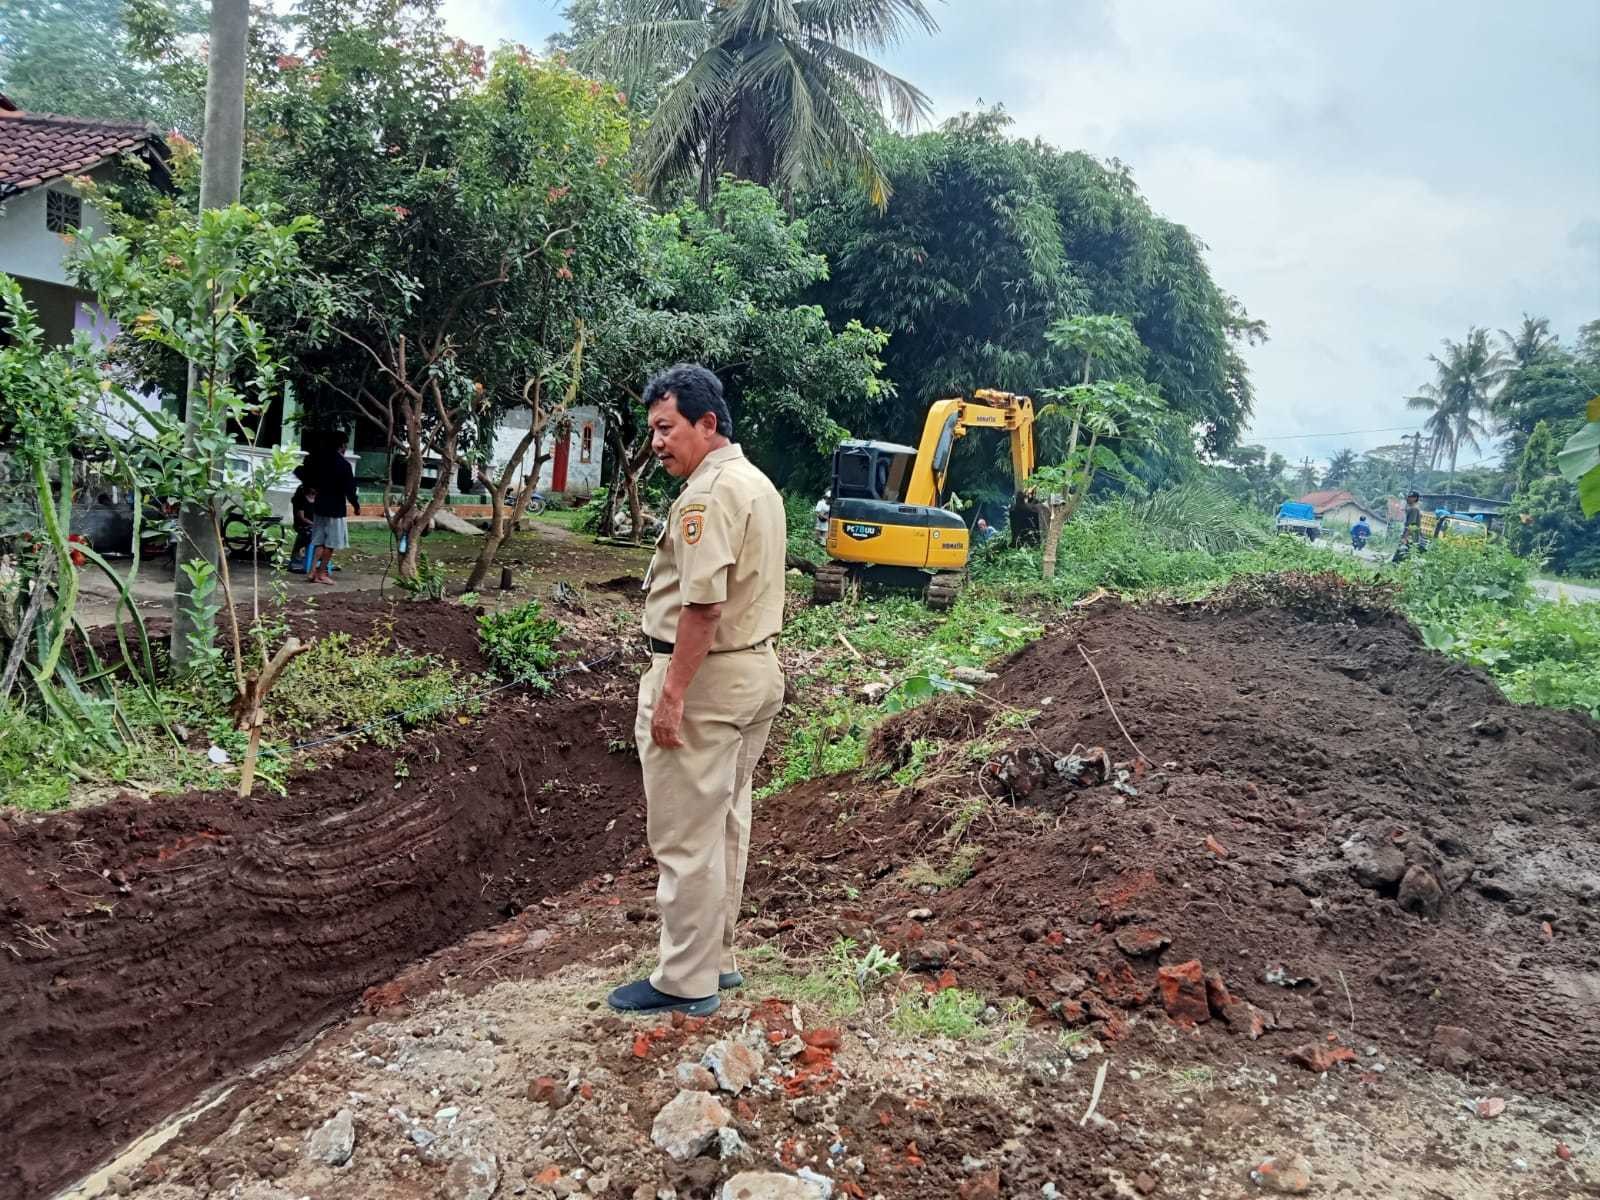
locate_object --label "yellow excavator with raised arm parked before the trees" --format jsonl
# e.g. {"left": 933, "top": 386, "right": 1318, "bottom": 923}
{"left": 813, "top": 389, "right": 1034, "bottom": 610}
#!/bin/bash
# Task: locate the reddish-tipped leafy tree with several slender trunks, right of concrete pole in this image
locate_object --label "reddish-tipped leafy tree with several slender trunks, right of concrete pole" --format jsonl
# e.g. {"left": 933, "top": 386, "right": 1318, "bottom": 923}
{"left": 246, "top": 8, "right": 638, "bottom": 578}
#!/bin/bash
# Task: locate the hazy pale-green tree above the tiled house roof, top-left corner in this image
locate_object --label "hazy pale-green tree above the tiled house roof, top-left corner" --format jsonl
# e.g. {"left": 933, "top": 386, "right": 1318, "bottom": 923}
{"left": 0, "top": 0, "right": 206, "bottom": 136}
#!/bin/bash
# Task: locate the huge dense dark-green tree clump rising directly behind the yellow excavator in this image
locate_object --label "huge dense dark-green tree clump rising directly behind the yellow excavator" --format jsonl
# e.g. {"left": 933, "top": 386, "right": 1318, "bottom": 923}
{"left": 802, "top": 110, "right": 1261, "bottom": 486}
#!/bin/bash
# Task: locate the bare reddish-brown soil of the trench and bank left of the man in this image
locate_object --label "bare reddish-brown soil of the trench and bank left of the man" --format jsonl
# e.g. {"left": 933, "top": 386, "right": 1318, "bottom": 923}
{"left": 0, "top": 597, "right": 643, "bottom": 1200}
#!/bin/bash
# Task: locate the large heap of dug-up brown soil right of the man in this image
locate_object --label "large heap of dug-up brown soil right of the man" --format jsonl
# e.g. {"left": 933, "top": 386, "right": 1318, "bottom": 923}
{"left": 750, "top": 605, "right": 1600, "bottom": 1096}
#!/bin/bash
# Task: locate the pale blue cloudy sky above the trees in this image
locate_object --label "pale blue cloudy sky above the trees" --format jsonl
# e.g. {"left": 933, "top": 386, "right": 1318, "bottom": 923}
{"left": 445, "top": 0, "right": 1600, "bottom": 466}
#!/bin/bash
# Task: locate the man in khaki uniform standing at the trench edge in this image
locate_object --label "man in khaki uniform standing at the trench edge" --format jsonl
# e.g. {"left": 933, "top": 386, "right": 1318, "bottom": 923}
{"left": 610, "top": 366, "right": 786, "bottom": 1016}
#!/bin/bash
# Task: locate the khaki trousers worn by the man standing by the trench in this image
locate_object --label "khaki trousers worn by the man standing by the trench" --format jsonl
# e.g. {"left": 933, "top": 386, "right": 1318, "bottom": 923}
{"left": 634, "top": 645, "right": 784, "bottom": 1000}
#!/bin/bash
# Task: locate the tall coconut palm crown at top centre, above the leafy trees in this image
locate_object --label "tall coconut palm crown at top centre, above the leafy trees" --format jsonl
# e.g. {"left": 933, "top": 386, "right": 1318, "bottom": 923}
{"left": 574, "top": 0, "right": 938, "bottom": 206}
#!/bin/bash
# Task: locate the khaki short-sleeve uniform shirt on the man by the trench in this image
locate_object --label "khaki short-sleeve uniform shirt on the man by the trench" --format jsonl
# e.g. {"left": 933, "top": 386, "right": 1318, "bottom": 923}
{"left": 643, "top": 445, "right": 787, "bottom": 654}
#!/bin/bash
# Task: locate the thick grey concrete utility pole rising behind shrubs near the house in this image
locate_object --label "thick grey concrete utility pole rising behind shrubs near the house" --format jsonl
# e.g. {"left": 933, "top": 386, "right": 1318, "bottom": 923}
{"left": 173, "top": 0, "right": 250, "bottom": 667}
